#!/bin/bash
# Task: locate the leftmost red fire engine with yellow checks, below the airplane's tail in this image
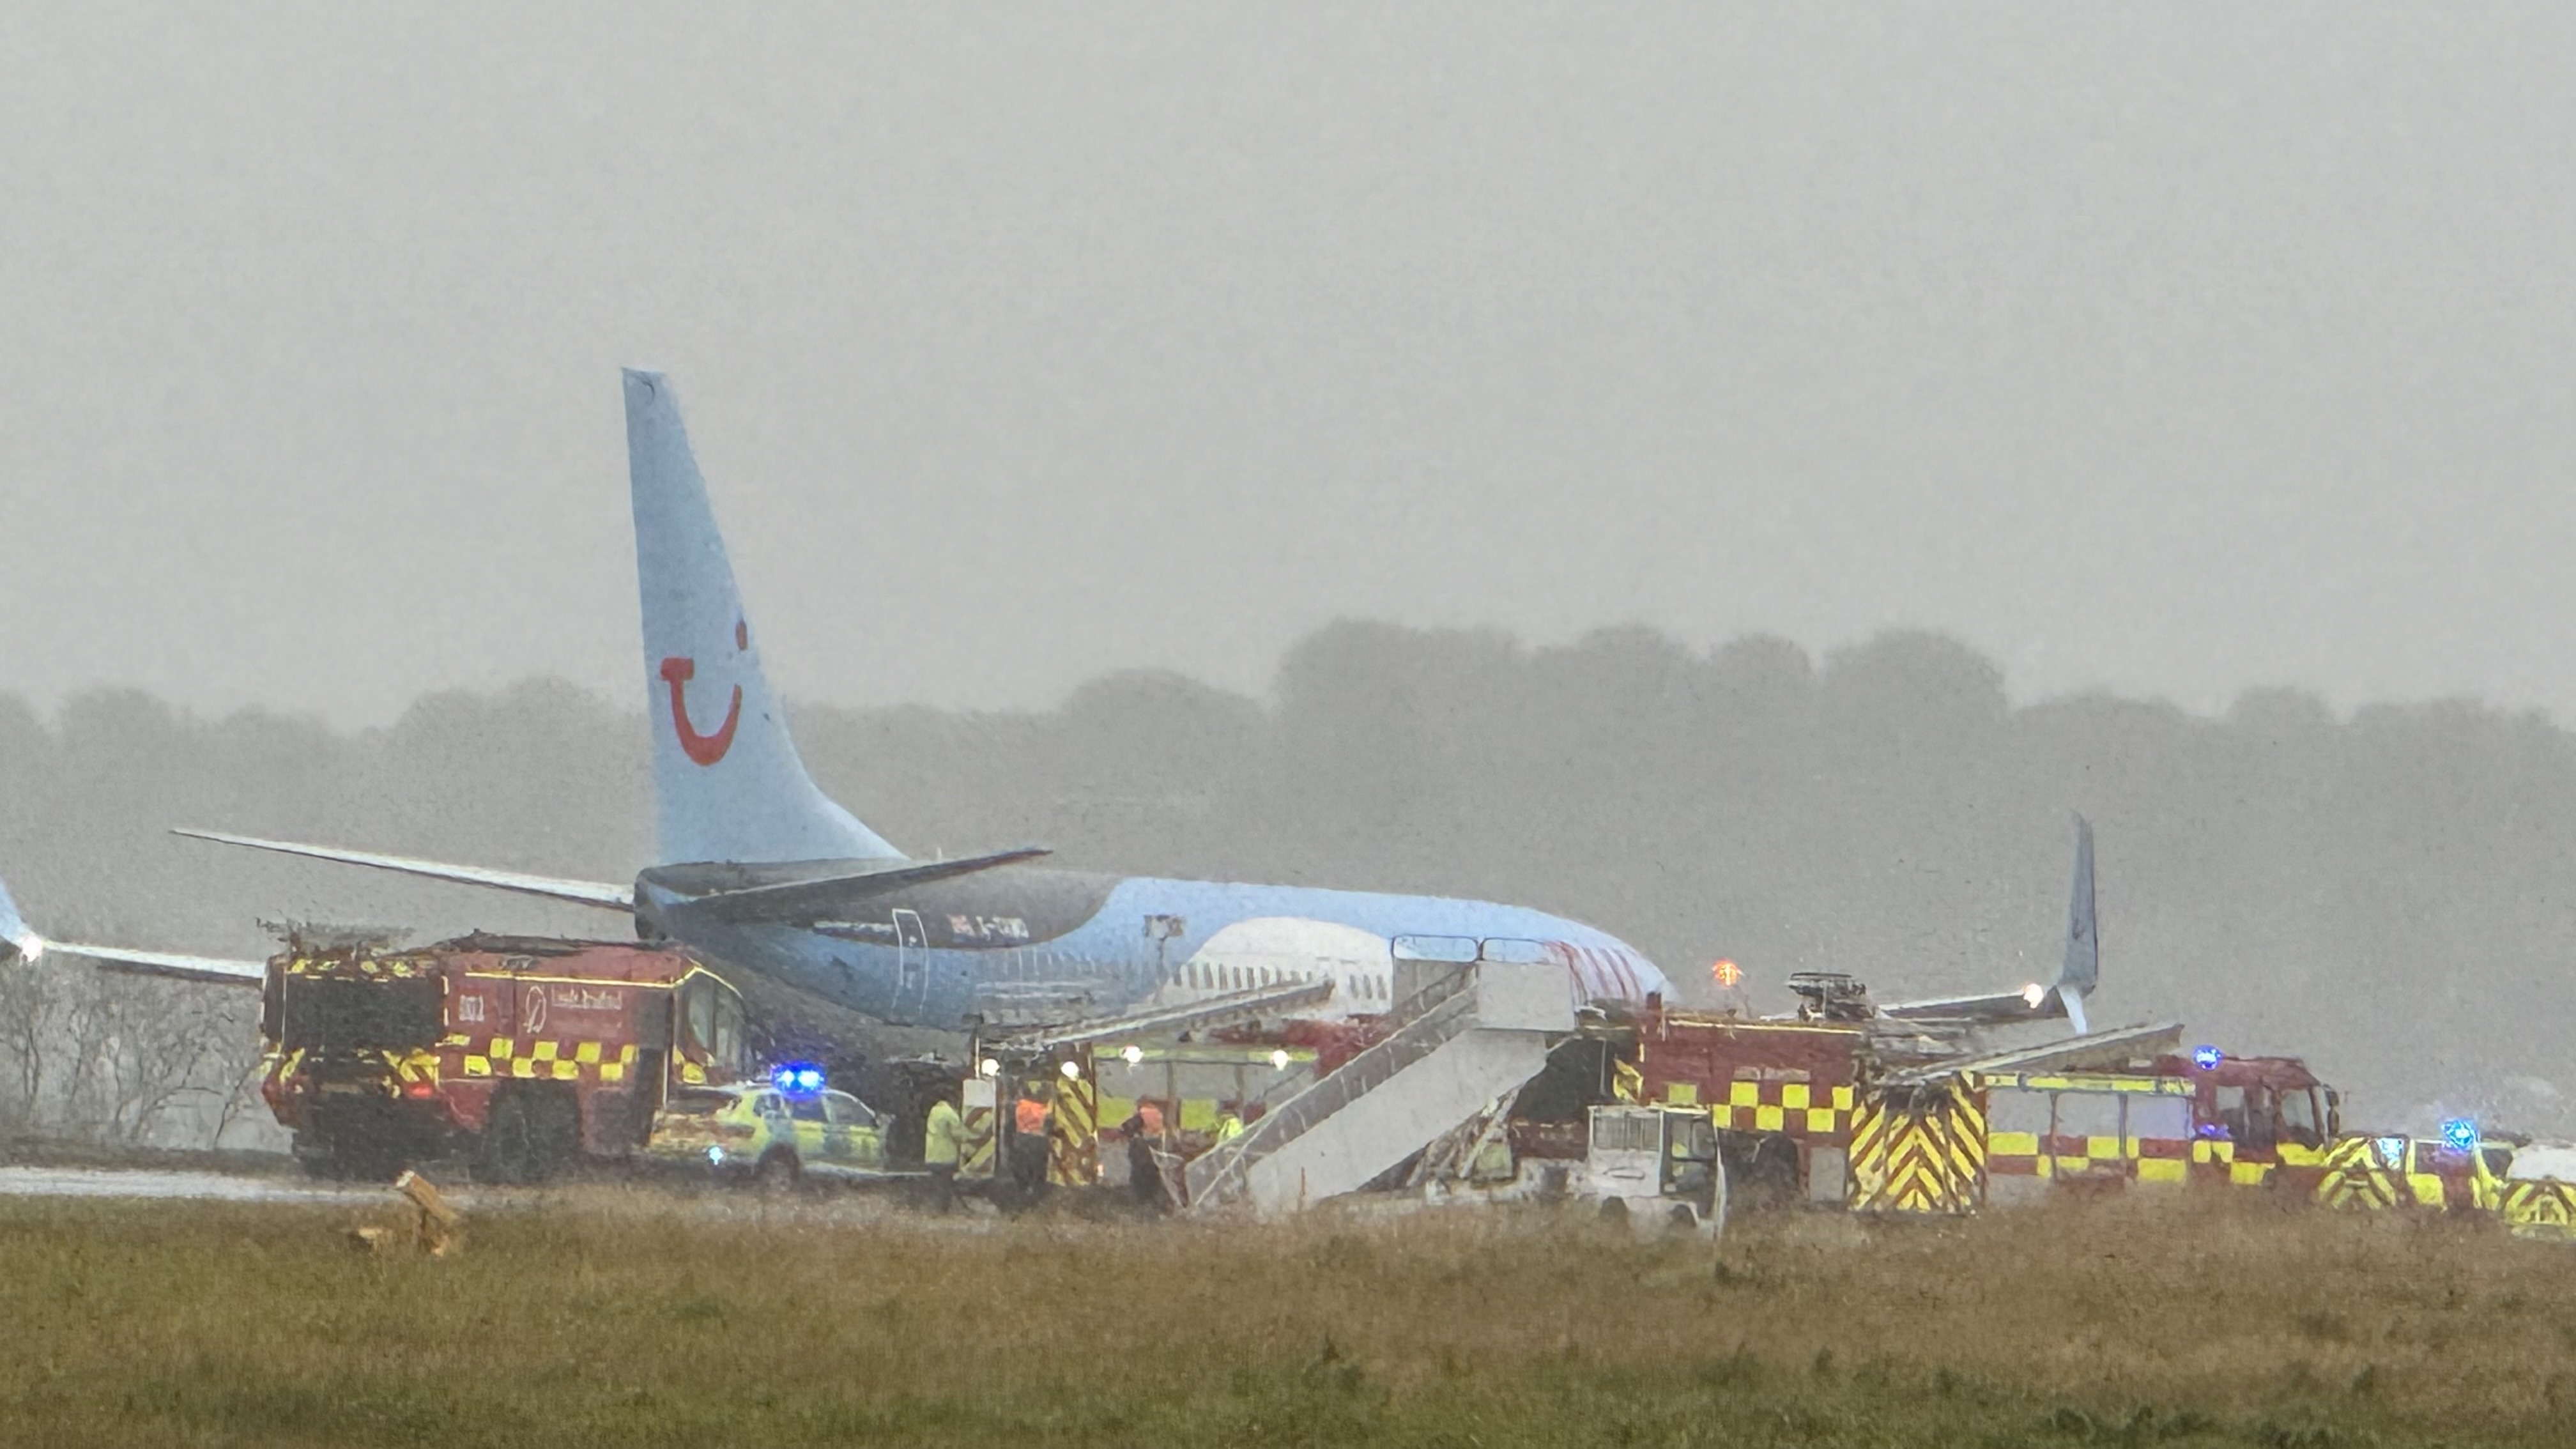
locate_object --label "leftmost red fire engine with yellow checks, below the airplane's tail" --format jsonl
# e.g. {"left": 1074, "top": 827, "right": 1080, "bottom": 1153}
{"left": 260, "top": 933, "right": 747, "bottom": 1183}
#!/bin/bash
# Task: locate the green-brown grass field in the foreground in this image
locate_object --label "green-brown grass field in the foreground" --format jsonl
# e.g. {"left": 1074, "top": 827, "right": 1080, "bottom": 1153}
{"left": 0, "top": 1188, "right": 2576, "bottom": 1449}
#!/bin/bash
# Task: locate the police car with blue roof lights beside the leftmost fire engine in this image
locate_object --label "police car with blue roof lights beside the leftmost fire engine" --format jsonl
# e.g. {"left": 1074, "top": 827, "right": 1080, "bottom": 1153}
{"left": 644, "top": 1065, "right": 909, "bottom": 1186}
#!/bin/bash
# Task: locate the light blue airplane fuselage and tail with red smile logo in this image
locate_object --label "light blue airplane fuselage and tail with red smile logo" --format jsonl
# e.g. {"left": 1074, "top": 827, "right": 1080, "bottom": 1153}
{"left": 178, "top": 369, "right": 1669, "bottom": 1031}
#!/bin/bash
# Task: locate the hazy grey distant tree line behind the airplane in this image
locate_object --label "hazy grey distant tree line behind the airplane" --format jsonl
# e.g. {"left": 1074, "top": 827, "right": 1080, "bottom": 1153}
{"left": 0, "top": 624, "right": 2576, "bottom": 1132}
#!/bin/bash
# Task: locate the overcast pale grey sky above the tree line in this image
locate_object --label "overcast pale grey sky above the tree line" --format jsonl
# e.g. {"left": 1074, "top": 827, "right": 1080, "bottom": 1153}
{"left": 0, "top": 0, "right": 2576, "bottom": 722}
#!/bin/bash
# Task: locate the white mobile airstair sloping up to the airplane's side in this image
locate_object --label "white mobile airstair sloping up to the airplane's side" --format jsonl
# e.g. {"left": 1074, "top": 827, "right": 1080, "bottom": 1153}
{"left": 1180, "top": 962, "right": 1574, "bottom": 1215}
